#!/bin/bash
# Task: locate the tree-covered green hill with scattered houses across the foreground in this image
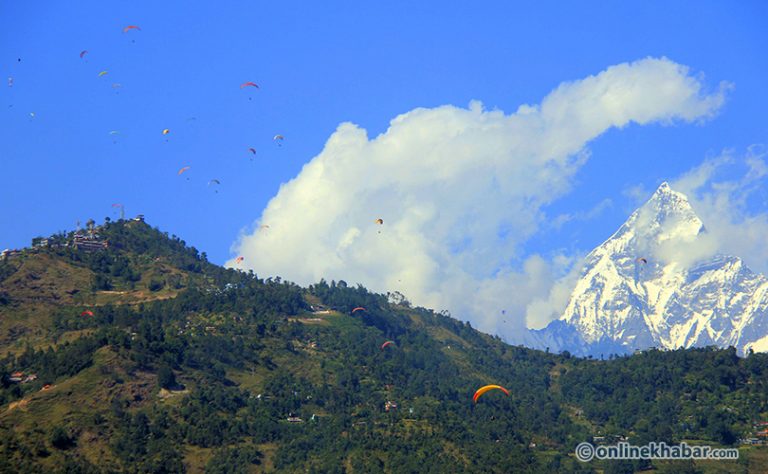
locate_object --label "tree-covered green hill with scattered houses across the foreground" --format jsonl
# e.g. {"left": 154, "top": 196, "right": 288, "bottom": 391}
{"left": 0, "top": 220, "right": 768, "bottom": 473}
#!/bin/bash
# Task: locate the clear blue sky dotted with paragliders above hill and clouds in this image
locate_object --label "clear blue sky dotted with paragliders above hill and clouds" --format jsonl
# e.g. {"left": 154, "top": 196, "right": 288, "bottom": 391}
{"left": 0, "top": 1, "right": 768, "bottom": 336}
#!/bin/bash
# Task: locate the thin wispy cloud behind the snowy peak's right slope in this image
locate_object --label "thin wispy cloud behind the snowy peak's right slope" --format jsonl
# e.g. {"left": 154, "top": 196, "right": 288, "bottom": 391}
{"left": 670, "top": 145, "right": 768, "bottom": 273}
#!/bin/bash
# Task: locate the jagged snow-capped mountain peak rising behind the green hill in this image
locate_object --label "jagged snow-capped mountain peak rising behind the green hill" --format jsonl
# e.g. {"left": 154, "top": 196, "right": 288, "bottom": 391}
{"left": 531, "top": 183, "right": 768, "bottom": 356}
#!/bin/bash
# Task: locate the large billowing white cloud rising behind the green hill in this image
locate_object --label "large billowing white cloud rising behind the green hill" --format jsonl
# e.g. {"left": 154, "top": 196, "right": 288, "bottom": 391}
{"left": 230, "top": 58, "right": 726, "bottom": 340}
